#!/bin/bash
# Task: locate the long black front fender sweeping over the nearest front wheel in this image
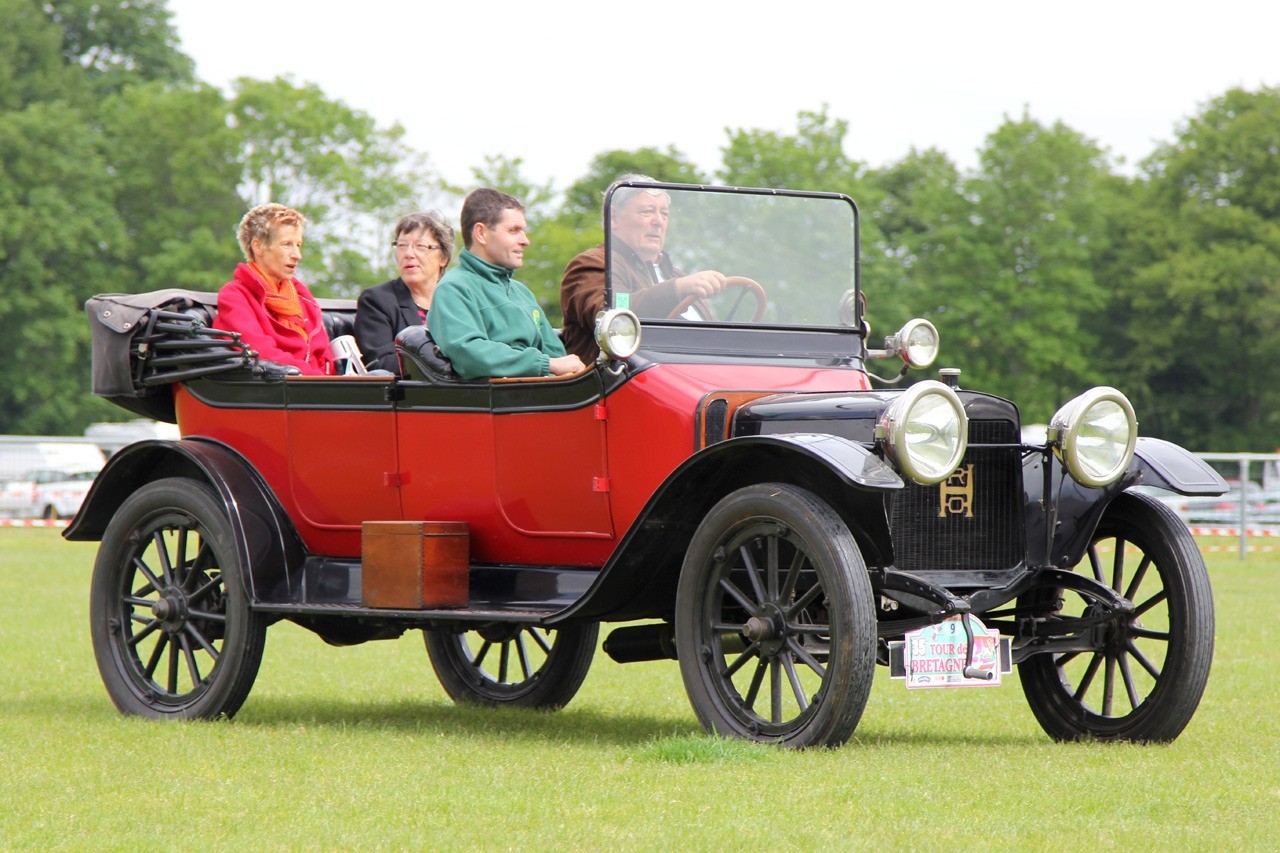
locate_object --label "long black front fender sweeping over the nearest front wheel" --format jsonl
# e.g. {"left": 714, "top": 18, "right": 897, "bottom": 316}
{"left": 548, "top": 433, "right": 904, "bottom": 622}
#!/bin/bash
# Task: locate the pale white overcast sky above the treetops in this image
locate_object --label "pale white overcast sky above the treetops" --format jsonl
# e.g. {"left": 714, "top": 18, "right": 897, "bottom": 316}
{"left": 169, "top": 0, "right": 1280, "bottom": 190}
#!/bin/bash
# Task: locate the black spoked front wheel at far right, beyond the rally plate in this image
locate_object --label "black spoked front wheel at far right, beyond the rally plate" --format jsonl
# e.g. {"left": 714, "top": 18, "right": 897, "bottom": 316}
{"left": 1018, "top": 492, "right": 1213, "bottom": 742}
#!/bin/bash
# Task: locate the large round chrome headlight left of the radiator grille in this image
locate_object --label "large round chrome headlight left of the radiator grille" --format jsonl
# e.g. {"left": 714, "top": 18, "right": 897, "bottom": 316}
{"left": 876, "top": 379, "right": 969, "bottom": 485}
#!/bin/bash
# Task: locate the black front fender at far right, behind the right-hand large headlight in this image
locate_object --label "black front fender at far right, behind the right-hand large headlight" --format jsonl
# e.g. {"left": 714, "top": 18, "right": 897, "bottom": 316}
{"left": 1023, "top": 438, "right": 1226, "bottom": 567}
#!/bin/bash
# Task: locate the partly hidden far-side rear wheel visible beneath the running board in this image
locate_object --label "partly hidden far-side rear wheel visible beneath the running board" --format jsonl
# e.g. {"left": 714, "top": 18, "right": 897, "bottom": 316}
{"left": 422, "top": 622, "right": 600, "bottom": 708}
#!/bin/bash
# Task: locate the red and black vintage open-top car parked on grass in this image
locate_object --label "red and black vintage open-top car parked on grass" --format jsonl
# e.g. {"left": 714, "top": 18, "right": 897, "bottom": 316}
{"left": 65, "top": 183, "right": 1225, "bottom": 747}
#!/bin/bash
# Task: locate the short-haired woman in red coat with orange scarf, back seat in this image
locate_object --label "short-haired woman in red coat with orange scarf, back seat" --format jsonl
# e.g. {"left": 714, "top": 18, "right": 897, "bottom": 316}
{"left": 214, "top": 204, "right": 333, "bottom": 375}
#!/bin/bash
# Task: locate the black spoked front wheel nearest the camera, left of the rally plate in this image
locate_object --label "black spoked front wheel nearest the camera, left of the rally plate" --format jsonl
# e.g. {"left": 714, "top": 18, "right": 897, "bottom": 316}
{"left": 676, "top": 483, "right": 876, "bottom": 748}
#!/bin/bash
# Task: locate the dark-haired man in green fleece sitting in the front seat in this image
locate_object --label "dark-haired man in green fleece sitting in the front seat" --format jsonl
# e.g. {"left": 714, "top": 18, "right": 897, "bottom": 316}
{"left": 428, "top": 187, "right": 585, "bottom": 379}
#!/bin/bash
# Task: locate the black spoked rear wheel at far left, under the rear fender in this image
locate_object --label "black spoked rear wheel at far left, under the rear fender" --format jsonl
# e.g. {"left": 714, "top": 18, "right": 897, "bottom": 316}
{"left": 90, "top": 478, "right": 266, "bottom": 720}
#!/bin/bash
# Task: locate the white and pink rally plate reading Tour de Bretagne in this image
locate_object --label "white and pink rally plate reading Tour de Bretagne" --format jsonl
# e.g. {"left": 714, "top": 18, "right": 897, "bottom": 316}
{"left": 888, "top": 616, "right": 1012, "bottom": 689}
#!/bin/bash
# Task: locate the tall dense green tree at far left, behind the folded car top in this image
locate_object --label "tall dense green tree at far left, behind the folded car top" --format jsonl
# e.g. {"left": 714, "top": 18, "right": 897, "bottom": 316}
{"left": 0, "top": 0, "right": 217, "bottom": 433}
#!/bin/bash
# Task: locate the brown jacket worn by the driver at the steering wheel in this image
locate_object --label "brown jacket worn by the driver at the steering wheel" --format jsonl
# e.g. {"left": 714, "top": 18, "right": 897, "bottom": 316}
{"left": 561, "top": 241, "right": 684, "bottom": 364}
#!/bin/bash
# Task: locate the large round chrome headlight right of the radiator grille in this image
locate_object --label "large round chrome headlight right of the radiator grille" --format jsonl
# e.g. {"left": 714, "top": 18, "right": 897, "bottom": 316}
{"left": 1048, "top": 386, "right": 1138, "bottom": 488}
